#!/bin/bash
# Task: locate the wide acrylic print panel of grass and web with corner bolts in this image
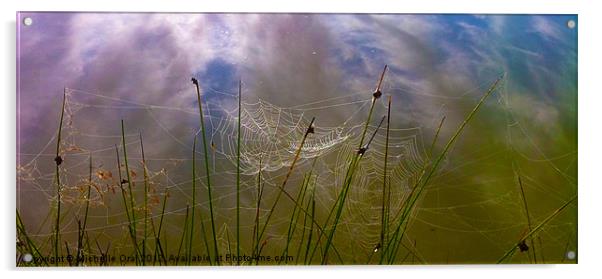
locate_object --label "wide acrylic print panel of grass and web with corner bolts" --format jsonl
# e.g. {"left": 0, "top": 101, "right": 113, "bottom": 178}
{"left": 16, "top": 12, "right": 578, "bottom": 266}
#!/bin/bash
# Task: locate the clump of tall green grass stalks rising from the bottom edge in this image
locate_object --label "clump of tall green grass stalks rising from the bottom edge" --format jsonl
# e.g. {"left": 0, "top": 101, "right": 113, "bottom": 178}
{"left": 17, "top": 70, "right": 576, "bottom": 266}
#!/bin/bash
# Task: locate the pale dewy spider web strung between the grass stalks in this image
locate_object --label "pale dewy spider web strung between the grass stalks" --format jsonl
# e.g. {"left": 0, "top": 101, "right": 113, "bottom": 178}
{"left": 17, "top": 75, "right": 576, "bottom": 263}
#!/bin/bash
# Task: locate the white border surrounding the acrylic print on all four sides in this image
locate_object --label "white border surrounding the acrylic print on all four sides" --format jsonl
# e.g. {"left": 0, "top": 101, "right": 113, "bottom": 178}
{"left": 0, "top": 0, "right": 602, "bottom": 279}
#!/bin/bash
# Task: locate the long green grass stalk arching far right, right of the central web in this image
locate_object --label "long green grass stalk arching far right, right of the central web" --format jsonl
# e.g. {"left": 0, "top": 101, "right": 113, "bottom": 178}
{"left": 384, "top": 76, "right": 503, "bottom": 264}
